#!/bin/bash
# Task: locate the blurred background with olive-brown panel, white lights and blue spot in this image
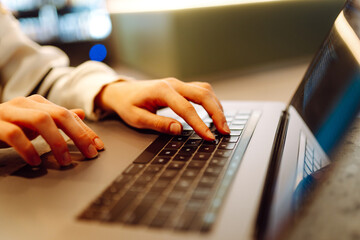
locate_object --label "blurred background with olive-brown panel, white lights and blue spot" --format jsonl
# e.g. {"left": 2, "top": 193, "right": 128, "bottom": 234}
{"left": 0, "top": 0, "right": 345, "bottom": 80}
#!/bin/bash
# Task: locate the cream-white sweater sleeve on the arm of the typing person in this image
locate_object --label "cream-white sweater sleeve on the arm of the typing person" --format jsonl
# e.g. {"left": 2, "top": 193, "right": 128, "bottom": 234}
{"left": 0, "top": 7, "right": 129, "bottom": 120}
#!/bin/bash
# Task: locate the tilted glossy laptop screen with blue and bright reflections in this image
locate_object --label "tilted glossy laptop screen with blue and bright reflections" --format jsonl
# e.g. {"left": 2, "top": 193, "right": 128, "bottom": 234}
{"left": 290, "top": 0, "right": 360, "bottom": 154}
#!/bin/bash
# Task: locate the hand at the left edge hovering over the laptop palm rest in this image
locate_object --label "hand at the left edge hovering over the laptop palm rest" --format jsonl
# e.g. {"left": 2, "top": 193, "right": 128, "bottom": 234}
{"left": 0, "top": 95, "right": 104, "bottom": 165}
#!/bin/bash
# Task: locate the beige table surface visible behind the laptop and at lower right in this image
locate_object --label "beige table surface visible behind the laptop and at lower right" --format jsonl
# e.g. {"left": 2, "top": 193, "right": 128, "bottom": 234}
{"left": 114, "top": 60, "right": 360, "bottom": 240}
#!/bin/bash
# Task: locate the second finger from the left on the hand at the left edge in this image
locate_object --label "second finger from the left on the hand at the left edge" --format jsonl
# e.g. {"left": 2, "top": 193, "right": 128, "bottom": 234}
{"left": 2, "top": 107, "right": 71, "bottom": 165}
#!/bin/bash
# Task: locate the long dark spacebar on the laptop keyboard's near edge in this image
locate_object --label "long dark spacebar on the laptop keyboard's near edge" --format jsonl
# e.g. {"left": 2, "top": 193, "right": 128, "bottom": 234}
{"left": 133, "top": 135, "right": 172, "bottom": 164}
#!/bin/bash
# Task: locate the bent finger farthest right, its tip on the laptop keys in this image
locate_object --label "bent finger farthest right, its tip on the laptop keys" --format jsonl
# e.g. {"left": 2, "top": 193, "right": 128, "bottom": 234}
{"left": 172, "top": 82, "right": 230, "bottom": 134}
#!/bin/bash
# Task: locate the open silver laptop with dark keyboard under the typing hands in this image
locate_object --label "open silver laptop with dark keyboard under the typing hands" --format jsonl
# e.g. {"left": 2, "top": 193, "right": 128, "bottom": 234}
{"left": 0, "top": 0, "right": 360, "bottom": 240}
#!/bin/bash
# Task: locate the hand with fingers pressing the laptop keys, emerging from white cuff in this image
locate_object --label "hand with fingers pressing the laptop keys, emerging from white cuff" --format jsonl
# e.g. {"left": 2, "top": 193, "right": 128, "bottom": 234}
{"left": 97, "top": 78, "right": 230, "bottom": 141}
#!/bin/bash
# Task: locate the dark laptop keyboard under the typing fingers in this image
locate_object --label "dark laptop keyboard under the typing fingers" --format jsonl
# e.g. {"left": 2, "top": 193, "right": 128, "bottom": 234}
{"left": 79, "top": 111, "right": 260, "bottom": 232}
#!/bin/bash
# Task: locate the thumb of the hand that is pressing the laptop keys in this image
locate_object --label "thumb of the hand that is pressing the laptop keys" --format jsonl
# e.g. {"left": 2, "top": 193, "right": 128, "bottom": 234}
{"left": 127, "top": 107, "right": 182, "bottom": 135}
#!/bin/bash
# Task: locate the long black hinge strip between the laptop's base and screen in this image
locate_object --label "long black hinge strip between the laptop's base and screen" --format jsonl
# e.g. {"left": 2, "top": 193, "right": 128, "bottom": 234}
{"left": 255, "top": 111, "right": 289, "bottom": 240}
